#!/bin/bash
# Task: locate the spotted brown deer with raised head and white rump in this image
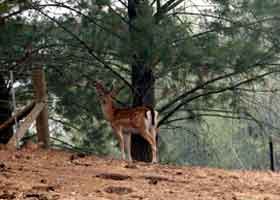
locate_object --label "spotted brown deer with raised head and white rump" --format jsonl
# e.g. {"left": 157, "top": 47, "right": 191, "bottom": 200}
{"left": 94, "top": 82, "right": 158, "bottom": 163}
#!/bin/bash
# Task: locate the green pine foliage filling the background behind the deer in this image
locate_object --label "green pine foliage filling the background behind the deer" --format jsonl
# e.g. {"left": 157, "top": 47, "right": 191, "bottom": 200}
{"left": 0, "top": 0, "right": 280, "bottom": 169}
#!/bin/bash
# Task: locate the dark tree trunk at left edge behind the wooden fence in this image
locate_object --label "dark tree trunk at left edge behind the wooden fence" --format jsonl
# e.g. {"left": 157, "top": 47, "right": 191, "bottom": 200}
{"left": 0, "top": 75, "right": 13, "bottom": 144}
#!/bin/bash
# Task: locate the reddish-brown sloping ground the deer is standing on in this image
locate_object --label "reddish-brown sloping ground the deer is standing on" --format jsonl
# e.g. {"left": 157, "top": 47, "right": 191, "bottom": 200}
{"left": 0, "top": 145, "right": 280, "bottom": 200}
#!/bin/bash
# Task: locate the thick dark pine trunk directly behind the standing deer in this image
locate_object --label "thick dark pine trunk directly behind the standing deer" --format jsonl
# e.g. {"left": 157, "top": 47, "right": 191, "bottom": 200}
{"left": 128, "top": 0, "right": 155, "bottom": 162}
